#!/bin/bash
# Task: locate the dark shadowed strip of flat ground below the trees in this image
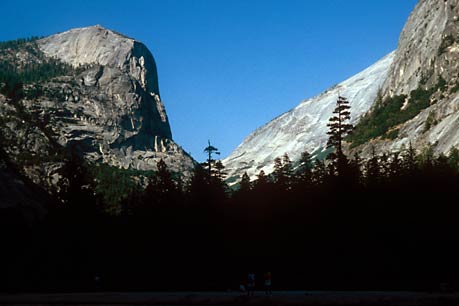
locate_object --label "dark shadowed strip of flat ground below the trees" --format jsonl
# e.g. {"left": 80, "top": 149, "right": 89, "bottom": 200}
{"left": 0, "top": 291, "right": 459, "bottom": 306}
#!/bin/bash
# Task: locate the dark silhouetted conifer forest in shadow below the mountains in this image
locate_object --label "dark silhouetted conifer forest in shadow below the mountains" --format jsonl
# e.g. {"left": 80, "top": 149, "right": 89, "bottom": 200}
{"left": 0, "top": 92, "right": 459, "bottom": 291}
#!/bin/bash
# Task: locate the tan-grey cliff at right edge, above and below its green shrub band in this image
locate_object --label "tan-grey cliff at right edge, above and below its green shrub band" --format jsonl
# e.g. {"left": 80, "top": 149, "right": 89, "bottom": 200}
{"left": 353, "top": 0, "right": 459, "bottom": 156}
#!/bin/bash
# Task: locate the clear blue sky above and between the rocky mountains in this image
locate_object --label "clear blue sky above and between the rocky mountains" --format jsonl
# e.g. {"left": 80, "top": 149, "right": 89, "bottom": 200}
{"left": 0, "top": 0, "right": 417, "bottom": 160}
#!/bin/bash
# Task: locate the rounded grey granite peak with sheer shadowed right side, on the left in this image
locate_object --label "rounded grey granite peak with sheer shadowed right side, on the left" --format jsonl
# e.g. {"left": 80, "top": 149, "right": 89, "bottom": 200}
{"left": 38, "top": 26, "right": 193, "bottom": 171}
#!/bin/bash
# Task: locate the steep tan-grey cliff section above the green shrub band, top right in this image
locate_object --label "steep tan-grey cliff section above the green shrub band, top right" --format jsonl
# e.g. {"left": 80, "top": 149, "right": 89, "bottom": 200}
{"left": 384, "top": 0, "right": 459, "bottom": 96}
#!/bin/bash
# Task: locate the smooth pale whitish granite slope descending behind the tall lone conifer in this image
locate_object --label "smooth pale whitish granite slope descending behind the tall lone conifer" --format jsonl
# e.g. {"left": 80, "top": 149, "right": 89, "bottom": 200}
{"left": 223, "top": 52, "right": 394, "bottom": 182}
